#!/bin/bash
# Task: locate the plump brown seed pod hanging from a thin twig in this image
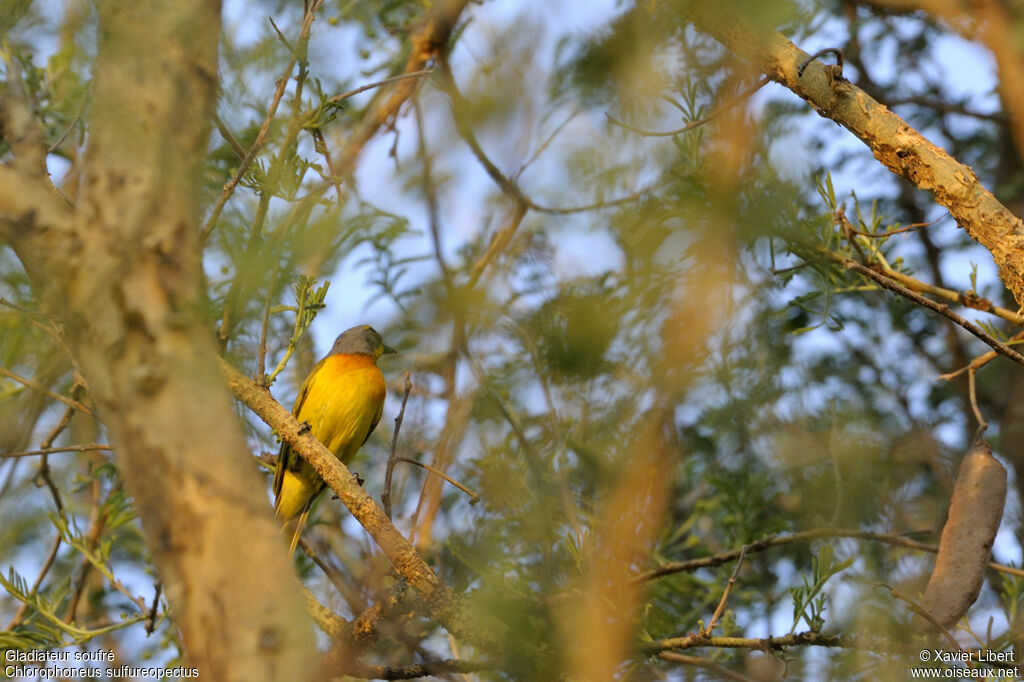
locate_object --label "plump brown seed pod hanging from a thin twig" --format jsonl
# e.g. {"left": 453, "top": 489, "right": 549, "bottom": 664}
{"left": 923, "top": 444, "right": 1007, "bottom": 628}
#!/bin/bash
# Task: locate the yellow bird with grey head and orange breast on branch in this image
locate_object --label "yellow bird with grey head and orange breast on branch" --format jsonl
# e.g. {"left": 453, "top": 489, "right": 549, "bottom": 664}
{"left": 273, "top": 325, "right": 395, "bottom": 555}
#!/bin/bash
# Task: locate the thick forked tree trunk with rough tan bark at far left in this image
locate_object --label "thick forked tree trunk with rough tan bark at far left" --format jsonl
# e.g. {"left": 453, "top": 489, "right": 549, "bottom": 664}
{"left": 0, "top": 0, "right": 313, "bottom": 682}
